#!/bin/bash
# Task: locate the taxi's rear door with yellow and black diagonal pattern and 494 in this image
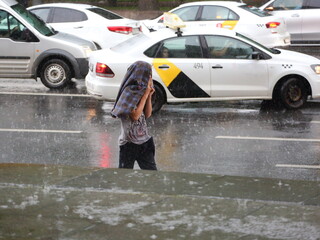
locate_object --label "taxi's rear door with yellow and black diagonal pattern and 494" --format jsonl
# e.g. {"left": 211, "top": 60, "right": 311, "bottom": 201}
{"left": 153, "top": 36, "right": 211, "bottom": 98}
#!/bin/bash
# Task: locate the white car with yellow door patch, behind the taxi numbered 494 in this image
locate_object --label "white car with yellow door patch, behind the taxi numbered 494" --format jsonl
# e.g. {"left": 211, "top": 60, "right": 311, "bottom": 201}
{"left": 142, "top": 1, "right": 290, "bottom": 47}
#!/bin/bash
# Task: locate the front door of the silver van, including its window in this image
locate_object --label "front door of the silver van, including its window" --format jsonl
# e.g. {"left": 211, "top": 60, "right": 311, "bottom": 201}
{"left": 0, "top": 10, "right": 35, "bottom": 77}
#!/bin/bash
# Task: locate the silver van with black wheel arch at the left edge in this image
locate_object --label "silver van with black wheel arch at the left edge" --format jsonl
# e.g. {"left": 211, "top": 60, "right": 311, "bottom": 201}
{"left": 0, "top": 0, "right": 96, "bottom": 88}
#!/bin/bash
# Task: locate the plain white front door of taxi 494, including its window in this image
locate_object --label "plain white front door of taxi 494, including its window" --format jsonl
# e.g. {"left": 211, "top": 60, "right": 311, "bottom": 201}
{"left": 205, "top": 35, "right": 269, "bottom": 98}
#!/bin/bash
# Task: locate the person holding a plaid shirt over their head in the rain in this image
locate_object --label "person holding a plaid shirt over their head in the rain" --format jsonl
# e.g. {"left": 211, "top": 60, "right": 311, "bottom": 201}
{"left": 111, "top": 61, "right": 157, "bottom": 170}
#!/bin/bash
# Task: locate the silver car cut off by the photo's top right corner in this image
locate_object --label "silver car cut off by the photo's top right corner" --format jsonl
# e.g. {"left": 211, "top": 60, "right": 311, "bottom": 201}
{"left": 260, "top": 0, "right": 320, "bottom": 45}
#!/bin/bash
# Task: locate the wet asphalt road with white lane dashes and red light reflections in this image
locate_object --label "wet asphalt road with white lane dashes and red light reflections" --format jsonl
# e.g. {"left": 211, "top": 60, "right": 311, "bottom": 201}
{"left": 0, "top": 47, "right": 320, "bottom": 181}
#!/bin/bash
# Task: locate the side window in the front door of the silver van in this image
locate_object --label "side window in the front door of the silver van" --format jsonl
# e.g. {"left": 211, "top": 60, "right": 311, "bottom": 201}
{"left": 0, "top": 10, "right": 27, "bottom": 41}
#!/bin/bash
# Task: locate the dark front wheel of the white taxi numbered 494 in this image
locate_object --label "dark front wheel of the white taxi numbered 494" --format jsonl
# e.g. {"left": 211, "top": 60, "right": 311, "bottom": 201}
{"left": 280, "top": 77, "right": 308, "bottom": 109}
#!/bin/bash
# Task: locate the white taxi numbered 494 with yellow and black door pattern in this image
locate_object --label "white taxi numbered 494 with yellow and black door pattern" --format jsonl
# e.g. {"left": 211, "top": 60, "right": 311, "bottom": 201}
{"left": 86, "top": 28, "right": 320, "bottom": 111}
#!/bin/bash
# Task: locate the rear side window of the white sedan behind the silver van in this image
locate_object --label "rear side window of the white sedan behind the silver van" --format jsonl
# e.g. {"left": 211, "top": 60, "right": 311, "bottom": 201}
{"left": 51, "top": 8, "right": 88, "bottom": 23}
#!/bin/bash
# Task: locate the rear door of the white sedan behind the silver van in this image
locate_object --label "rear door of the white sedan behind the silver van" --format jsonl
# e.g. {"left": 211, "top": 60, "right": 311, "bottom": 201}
{"left": 48, "top": 7, "right": 90, "bottom": 37}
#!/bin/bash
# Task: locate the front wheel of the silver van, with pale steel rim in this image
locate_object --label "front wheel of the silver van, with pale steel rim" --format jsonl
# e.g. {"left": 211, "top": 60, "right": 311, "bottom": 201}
{"left": 40, "top": 59, "right": 71, "bottom": 89}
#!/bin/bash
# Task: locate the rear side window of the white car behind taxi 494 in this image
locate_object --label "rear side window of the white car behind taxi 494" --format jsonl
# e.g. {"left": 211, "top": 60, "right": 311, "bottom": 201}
{"left": 200, "top": 6, "right": 239, "bottom": 21}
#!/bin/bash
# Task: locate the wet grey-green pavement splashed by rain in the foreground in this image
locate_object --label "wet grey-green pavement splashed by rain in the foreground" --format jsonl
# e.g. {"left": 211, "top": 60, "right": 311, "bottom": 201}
{"left": 0, "top": 164, "right": 320, "bottom": 240}
